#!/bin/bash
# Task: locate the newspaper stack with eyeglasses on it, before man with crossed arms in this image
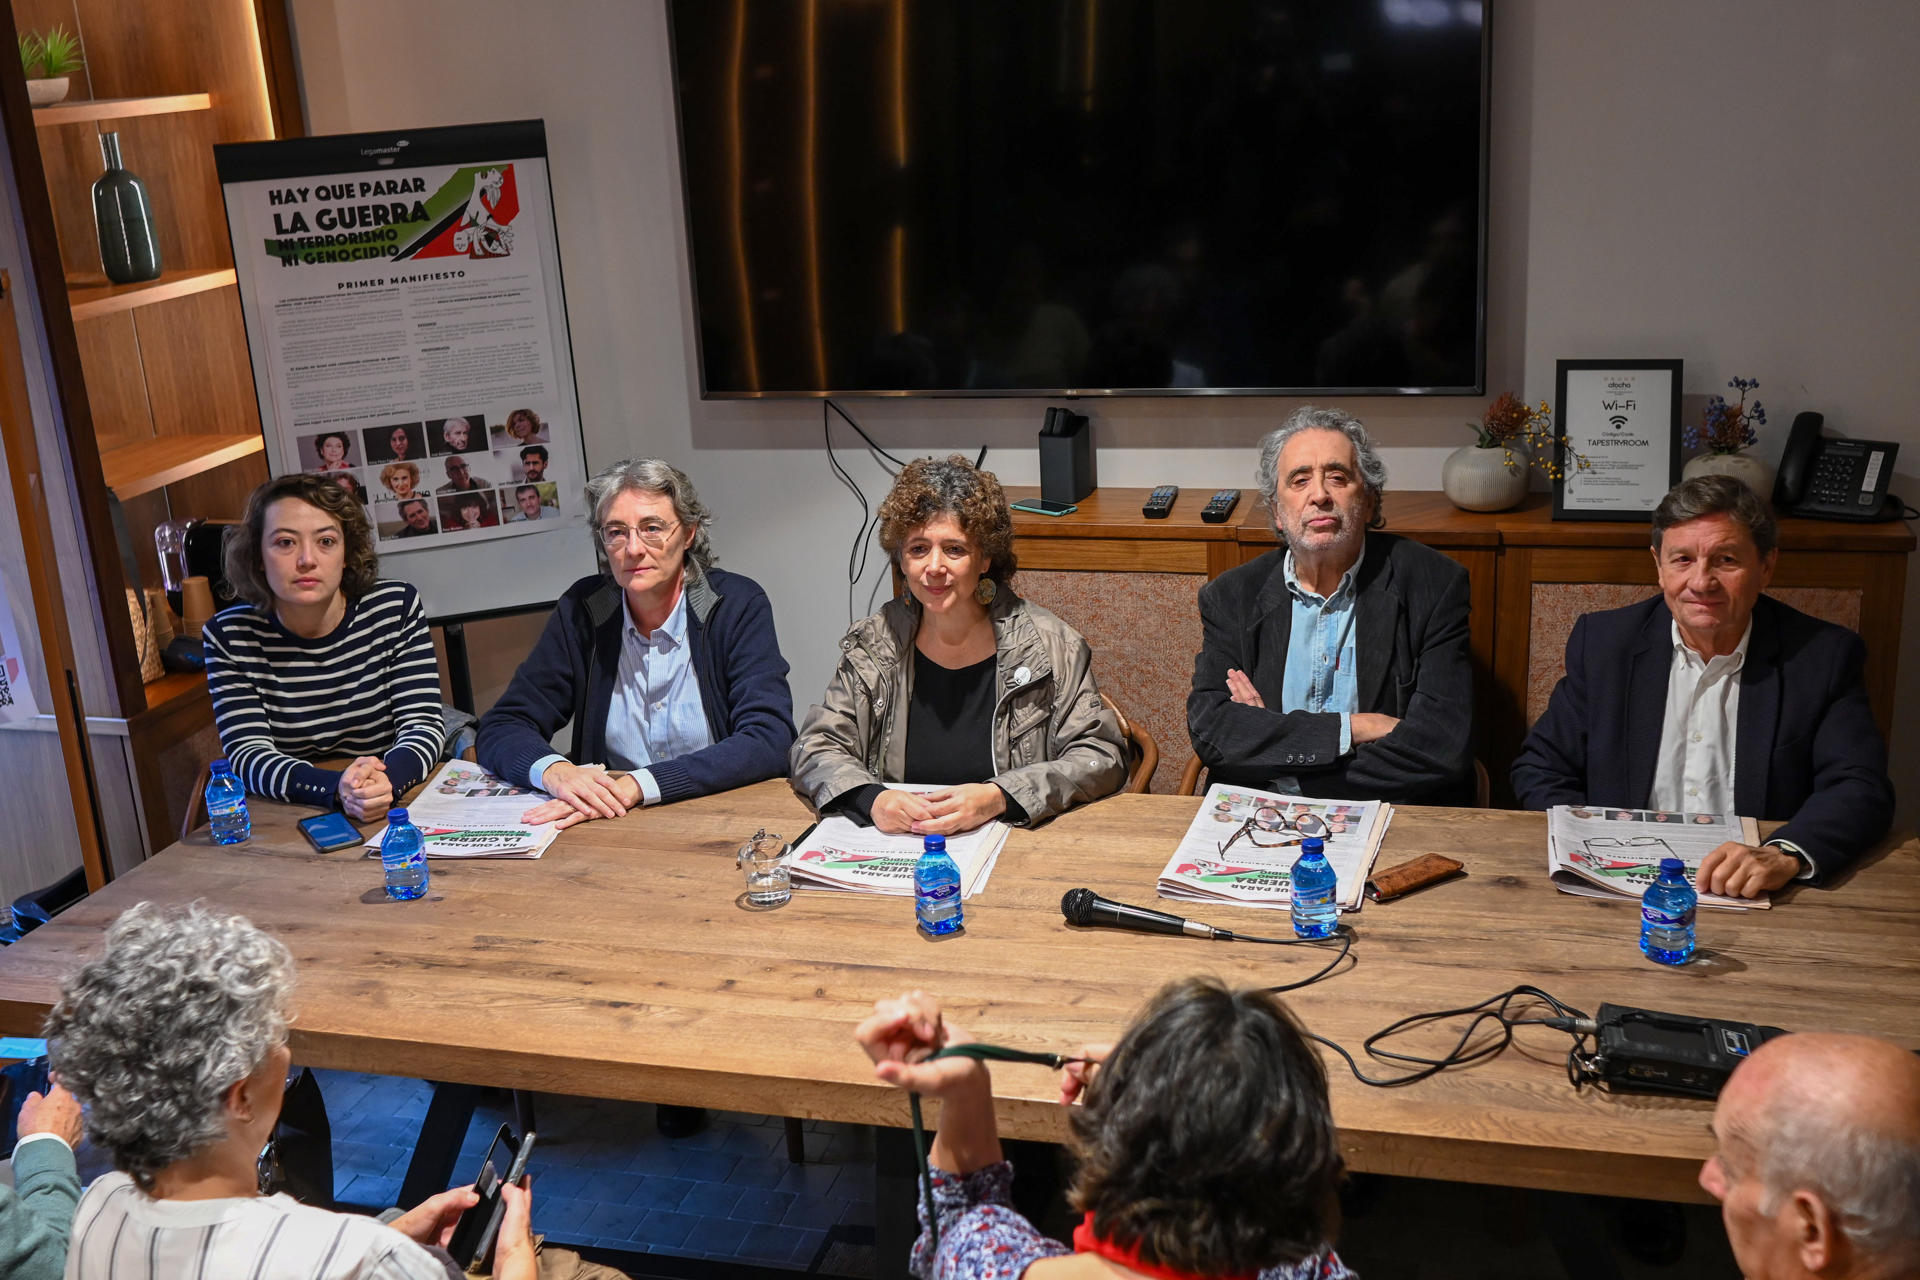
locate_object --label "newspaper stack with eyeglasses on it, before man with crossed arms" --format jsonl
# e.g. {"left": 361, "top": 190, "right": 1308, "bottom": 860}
{"left": 1160, "top": 783, "right": 1394, "bottom": 912}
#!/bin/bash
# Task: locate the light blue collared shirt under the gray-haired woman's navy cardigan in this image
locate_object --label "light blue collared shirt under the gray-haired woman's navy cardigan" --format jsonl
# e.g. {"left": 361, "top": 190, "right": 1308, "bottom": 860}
{"left": 532, "top": 589, "right": 714, "bottom": 804}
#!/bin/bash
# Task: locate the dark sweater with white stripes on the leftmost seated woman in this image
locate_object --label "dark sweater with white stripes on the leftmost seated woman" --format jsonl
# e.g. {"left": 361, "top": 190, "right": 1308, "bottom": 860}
{"left": 204, "top": 581, "right": 445, "bottom": 808}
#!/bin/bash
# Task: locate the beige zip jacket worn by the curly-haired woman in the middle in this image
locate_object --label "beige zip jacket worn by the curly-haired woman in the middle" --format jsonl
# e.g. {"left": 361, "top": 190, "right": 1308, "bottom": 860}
{"left": 787, "top": 587, "right": 1127, "bottom": 823}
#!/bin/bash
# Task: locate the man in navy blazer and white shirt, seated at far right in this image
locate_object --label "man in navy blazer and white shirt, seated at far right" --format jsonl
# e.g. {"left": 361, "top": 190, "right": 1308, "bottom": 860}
{"left": 1513, "top": 476, "right": 1893, "bottom": 898}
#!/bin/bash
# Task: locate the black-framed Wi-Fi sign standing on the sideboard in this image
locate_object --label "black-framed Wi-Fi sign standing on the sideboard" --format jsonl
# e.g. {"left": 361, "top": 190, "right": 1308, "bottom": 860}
{"left": 1549, "top": 361, "right": 1682, "bottom": 520}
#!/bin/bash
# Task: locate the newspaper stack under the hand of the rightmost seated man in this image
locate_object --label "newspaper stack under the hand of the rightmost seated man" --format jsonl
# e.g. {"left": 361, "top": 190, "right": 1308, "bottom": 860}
{"left": 1548, "top": 804, "right": 1772, "bottom": 912}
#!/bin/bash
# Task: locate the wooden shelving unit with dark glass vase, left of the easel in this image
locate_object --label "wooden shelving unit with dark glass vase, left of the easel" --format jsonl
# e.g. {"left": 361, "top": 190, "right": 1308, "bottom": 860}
{"left": 0, "top": 0, "right": 303, "bottom": 867}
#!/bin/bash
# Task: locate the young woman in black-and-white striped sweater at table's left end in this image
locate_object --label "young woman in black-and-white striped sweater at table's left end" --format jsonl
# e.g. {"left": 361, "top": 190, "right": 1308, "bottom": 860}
{"left": 205, "top": 474, "right": 445, "bottom": 821}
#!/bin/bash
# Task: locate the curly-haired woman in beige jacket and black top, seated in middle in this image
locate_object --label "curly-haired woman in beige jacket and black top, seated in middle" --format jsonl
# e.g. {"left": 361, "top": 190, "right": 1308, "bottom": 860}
{"left": 789, "top": 455, "right": 1127, "bottom": 835}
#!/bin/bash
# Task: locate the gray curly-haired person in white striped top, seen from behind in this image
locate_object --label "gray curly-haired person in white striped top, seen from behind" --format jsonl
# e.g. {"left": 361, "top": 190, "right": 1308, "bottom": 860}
{"left": 46, "top": 902, "right": 556, "bottom": 1280}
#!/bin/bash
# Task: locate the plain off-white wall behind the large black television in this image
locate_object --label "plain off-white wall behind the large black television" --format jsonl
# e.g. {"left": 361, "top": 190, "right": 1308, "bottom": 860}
{"left": 290, "top": 0, "right": 1920, "bottom": 823}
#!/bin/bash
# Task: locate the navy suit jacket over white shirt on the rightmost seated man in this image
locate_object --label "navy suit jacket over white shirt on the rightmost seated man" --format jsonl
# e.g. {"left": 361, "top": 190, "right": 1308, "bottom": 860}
{"left": 1513, "top": 595, "right": 1893, "bottom": 879}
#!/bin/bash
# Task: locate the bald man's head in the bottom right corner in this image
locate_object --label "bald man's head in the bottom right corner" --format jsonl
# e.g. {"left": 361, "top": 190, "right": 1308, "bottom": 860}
{"left": 1701, "top": 1034, "right": 1920, "bottom": 1278}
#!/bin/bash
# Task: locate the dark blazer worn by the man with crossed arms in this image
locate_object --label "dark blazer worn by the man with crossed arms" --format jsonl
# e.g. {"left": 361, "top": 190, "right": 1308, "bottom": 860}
{"left": 1187, "top": 533, "right": 1473, "bottom": 804}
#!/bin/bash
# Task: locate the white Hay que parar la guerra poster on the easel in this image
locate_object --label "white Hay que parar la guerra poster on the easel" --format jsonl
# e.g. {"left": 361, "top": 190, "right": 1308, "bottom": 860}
{"left": 213, "top": 121, "right": 588, "bottom": 568}
